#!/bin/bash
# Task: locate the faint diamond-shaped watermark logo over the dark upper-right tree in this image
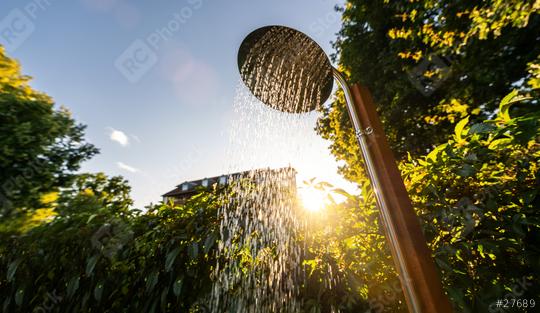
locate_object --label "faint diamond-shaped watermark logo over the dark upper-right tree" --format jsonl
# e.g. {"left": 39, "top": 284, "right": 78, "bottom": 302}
{"left": 407, "top": 54, "right": 450, "bottom": 97}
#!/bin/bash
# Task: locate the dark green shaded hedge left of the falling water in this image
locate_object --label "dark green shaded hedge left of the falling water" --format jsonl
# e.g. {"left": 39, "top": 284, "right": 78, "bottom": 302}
{"left": 0, "top": 174, "right": 219, "bottom": 312}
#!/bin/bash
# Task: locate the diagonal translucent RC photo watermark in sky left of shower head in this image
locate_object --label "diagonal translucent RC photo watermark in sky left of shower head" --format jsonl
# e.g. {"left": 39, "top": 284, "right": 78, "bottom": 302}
{"left": 114, "top": 0, "right": 203, "bottom": 83}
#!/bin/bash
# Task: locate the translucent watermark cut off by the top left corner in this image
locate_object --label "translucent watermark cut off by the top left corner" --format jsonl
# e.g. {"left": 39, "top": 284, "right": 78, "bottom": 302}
{"left": 0, "top": 0, "right": 53, "bottom": 53}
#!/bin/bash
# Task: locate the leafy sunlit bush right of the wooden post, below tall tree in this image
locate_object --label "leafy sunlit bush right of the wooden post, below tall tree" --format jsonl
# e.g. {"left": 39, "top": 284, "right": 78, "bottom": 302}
{"left": 402, "top": 92, "right": 540, "bottom": 312}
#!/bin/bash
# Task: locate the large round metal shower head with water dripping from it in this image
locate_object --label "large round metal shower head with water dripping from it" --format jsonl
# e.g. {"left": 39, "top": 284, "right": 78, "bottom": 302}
{"left": 238, "top": 26, "right": 334, "bottom": 113}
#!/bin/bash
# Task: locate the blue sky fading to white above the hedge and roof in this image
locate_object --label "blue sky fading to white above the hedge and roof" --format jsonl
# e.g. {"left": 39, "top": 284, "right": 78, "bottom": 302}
{"left": 0, "top": 0, "right": 350, "bottom": 206}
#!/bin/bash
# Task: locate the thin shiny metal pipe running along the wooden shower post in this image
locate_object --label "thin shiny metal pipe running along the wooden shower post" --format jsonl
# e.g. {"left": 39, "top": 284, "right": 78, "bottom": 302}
{"left": 332, "top": 67, "right": 421, "bottom": 313}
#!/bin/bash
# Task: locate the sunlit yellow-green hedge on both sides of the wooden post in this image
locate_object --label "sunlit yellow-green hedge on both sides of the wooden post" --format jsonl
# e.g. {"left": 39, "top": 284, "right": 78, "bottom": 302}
{"left": 305, "top": 90, "right": 540, "bottom": 312}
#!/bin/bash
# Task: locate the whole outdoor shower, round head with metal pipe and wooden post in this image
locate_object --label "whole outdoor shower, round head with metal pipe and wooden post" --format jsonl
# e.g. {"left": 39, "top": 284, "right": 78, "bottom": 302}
{"left": 238, "top": 26, "right": 452, "bottom": 313}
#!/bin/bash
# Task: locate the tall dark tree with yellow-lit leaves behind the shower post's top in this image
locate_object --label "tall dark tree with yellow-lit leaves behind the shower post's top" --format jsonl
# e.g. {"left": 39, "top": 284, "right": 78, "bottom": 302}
{"left": 319, "top": 0, "right": 540, "bottom": 176}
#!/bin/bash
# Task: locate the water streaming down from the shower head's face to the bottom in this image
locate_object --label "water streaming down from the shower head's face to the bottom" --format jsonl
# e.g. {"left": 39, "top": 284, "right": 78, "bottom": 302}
{"left": 210, "top": 27, "right": 340, "bottom": 313}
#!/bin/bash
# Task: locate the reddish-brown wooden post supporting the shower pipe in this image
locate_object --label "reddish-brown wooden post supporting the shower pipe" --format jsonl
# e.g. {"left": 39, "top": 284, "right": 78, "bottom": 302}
{"left": 351, "top": 84, "right": 452, "bottom": 313}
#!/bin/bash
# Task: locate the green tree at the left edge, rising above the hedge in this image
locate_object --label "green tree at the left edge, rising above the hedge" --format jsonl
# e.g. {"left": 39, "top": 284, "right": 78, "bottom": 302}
{"left": 0, "top": 46, "right": 97, "bottom": 218}
